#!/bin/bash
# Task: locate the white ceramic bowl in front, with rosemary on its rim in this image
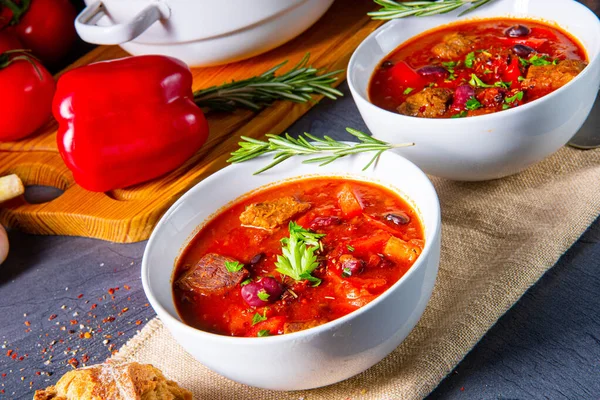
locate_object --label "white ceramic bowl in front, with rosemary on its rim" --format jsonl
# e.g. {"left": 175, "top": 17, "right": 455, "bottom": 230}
{"left": 142, "top": 152, "right": 441, "bottom": 390}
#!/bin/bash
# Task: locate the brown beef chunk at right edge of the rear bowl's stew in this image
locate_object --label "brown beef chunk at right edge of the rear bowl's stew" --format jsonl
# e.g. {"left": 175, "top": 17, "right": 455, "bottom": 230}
{"left": 521, "top": 60, "right": 587, "bottom": 92}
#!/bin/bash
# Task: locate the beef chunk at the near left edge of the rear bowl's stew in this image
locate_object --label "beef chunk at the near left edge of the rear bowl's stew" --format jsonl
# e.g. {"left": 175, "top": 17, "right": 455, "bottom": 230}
{"left": 398, "top": 88, "right": 453, "bottom": 118}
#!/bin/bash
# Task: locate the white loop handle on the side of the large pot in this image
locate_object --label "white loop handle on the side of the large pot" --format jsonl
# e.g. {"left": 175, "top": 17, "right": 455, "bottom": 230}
{"left": 75, "top": 0, "right": 171, "bottom": 44}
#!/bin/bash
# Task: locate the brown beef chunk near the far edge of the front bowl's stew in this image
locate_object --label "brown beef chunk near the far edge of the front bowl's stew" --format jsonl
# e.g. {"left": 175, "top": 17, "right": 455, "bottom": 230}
{"left": 240, "top": 197, "right": 310, "bottom": 229}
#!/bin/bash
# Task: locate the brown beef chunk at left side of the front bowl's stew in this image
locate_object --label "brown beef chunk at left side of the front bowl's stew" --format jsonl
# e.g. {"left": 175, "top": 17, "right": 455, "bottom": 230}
{"left": 177, "top": 253, "right": 248, "bottom": 294}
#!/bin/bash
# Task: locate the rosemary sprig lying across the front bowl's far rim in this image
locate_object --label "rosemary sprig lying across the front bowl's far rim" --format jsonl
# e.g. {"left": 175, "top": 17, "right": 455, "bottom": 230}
{"left": 227, "top": 128, "right": 414, "bottom": 175}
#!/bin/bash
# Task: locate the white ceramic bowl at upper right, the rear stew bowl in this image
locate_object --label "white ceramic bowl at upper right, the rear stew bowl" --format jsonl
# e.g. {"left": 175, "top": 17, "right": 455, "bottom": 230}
{"left": 348, "top": 0, "right": 600, "bottom": 181}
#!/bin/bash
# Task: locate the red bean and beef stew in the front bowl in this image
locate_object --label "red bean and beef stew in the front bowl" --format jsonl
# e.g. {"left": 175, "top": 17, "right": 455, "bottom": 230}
{"left": 173, "top": 178, "right": 424, "bottom": 337}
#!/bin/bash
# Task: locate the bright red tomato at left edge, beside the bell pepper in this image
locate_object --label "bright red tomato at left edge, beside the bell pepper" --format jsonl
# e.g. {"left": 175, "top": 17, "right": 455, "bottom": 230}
{"left": 0, "top": 48, "right": 56, "bottom": 141}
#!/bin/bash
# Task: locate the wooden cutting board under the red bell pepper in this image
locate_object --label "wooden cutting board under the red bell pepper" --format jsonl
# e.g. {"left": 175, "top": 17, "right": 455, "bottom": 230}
{"left": 0, "top": 0, "right": 381, "bottom": 243}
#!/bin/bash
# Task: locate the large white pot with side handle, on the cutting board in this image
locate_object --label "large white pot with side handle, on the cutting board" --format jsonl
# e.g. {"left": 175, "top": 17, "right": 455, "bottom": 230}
{"left": 75, "top": 0, "right": 333, "bottom": 67}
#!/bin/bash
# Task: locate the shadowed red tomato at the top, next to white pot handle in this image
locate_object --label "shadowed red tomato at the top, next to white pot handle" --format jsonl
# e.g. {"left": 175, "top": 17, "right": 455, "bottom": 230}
{"left": 0, "top": 0, "right": 77, "bottom": 65}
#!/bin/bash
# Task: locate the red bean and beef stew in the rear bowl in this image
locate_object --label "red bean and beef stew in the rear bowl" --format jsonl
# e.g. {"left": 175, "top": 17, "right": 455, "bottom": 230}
{"left": 369, "top": 18, "right": 587, "bottom": 118}
